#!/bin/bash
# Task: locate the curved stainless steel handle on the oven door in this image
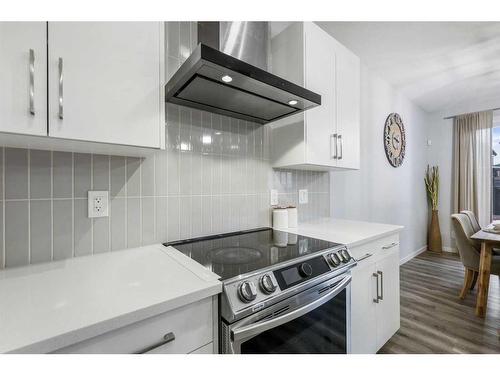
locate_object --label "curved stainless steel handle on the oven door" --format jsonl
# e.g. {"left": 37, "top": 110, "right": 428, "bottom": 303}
{"left": 231, "top": 275, "right": 351, "bottom": 341}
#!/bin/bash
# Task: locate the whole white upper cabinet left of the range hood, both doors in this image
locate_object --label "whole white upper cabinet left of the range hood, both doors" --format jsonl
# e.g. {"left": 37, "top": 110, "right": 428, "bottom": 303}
{"left": 0, "top": 22, "right": 165, "bottom": 156}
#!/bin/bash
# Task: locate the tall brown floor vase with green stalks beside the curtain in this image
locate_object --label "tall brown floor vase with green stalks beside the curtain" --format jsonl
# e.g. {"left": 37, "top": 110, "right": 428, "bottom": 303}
{"left": 424, "top": 165, "right": 443, "bottom": 253}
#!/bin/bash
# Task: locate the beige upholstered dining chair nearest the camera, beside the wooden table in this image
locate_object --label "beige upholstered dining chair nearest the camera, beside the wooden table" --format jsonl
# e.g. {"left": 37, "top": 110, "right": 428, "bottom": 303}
{"left": 451, "top": 213, "right": 500, "bottom": 299}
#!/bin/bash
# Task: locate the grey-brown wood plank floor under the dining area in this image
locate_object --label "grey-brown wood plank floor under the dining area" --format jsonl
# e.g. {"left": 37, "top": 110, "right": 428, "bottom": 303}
{"left": 379, "top": 252, "right": 500, "bottom": 354}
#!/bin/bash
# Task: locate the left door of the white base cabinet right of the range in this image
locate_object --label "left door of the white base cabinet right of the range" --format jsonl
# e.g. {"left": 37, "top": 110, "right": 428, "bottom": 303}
{"left": 351, "top": 260, "right": 377, "bottom": 354}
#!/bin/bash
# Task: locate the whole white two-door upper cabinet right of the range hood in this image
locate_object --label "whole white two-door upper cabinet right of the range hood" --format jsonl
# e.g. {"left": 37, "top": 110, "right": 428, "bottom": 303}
{"left": 270, "top": 22, "right": 360, "bottom": 170}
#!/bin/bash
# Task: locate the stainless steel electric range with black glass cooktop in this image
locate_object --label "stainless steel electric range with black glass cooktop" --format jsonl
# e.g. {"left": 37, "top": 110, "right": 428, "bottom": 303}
{"left": 165, "top": 228, "right": 356, "bottom": 354}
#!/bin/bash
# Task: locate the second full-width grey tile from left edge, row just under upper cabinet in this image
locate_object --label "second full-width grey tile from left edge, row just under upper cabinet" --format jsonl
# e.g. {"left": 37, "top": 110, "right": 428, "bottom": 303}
{"left": 30, "top": 150, "right": 51, "bottom": 199}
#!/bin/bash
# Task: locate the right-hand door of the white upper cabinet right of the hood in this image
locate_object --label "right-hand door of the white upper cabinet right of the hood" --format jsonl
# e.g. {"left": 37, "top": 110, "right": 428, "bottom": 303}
{"left": 336, "top": 45, "right": 361, "bottom": 169}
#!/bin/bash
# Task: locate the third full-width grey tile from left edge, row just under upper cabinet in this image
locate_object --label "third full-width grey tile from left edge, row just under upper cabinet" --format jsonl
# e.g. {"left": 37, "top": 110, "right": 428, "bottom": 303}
{"left": 52, "top": 151, "right": 73, "bottom": 198}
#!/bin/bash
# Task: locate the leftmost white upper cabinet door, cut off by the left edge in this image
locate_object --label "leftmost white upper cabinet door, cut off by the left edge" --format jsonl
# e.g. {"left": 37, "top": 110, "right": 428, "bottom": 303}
{"left": 0, "top": 22, "right": 47, "bottom": 135}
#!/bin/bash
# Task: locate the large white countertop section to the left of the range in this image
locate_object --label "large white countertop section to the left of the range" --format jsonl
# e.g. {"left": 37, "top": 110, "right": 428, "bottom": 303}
{"left": 0, "top": 244, "right": 222, "bottom": 353}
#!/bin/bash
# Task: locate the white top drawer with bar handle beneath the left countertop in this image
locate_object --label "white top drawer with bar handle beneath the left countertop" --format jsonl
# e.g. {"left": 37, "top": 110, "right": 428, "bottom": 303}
{"left": 57, "top": 298, "right": 213, "bottom": 354}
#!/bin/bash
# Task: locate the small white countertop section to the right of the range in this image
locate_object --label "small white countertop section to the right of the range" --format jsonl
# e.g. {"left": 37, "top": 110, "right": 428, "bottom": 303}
{"left": 286, "top": 218, "right": 403, "bottom": 247}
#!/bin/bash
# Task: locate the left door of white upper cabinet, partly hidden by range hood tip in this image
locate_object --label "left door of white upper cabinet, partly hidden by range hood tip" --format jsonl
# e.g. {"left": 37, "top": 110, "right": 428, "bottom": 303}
{"left": 304, "top": 22, "right": 336, "bottom": 166}
